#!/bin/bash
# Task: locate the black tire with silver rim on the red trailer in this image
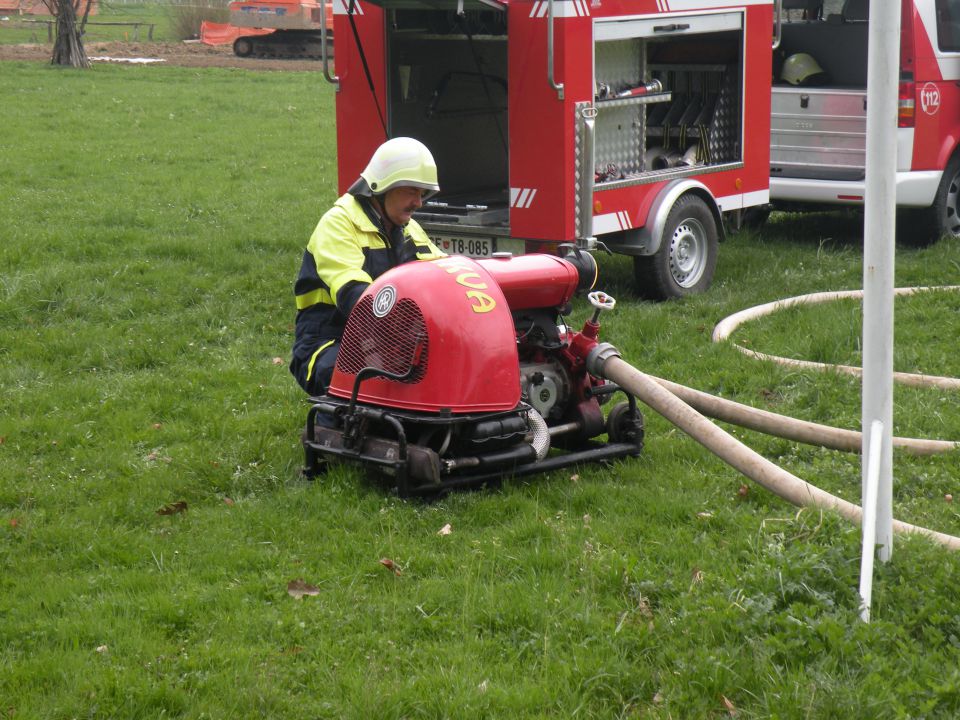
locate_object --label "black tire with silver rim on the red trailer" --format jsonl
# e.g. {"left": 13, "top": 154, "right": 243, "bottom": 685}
{"left": 633, "top": 193, "right": 720, "bottom": 300}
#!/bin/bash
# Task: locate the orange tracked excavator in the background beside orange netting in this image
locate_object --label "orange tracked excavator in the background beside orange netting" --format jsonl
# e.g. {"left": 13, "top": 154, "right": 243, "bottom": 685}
{"left": 230, "top": 0, "right": 333, "bottom": 58}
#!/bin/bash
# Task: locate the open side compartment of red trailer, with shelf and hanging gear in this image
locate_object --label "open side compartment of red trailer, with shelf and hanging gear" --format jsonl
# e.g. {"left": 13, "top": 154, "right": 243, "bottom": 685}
{"left": 594, "top": 13, "right": 744, "bottom": 184}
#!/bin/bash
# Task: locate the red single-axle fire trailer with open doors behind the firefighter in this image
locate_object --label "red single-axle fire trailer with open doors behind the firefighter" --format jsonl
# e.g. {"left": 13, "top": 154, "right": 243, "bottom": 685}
{"left": 324, "top": 0, "right": 779, "bottom": 299}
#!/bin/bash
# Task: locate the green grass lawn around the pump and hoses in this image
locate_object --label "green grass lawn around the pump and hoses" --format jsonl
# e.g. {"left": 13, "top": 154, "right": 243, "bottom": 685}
{"left": 0, "top": 63, "right": 960, "bottom": 720}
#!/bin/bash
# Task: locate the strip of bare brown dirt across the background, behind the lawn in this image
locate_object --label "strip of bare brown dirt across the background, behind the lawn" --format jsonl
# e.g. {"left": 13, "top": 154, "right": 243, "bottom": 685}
{"left": 0, "top": 42, "right": 321, "bottom": 71}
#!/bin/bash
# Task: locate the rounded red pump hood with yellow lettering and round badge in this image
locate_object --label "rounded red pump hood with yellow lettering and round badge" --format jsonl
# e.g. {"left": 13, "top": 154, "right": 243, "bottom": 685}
{"left": 329, "top": 256, "right": 520, "bottom": 413}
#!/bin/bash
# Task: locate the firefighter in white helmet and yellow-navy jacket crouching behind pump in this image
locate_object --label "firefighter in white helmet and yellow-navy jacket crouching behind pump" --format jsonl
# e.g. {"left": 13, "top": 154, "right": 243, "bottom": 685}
{"left": 290, "top": 137, "right": 444, "bottom": 396}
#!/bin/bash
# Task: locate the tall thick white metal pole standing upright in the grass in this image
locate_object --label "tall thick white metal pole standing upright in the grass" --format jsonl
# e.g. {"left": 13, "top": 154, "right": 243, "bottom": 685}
{"left": 861, "top": 0, "right": 900, "bottom": 562}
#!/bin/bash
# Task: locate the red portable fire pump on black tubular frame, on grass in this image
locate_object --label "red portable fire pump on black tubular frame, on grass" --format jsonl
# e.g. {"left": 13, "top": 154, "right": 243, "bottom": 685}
{"left": 303, "top": 250, "right": 643, "bottom": 497}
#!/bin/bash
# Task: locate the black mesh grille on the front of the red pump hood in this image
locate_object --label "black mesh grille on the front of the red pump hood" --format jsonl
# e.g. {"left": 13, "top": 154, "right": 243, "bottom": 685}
{"left": 337, "top": 295, "right": 429, "bottom": 383}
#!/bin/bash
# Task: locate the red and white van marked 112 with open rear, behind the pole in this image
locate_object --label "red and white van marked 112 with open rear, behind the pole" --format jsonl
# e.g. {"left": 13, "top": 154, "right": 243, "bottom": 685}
{"left": 757, "top": 0, "right": 960, "bottom": 244}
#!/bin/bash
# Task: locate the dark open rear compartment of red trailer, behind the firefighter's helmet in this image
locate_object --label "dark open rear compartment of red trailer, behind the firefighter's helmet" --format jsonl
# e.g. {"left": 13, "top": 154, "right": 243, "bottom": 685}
{"left": 387, "top": 9, "right": 509, "bottom": 227}
